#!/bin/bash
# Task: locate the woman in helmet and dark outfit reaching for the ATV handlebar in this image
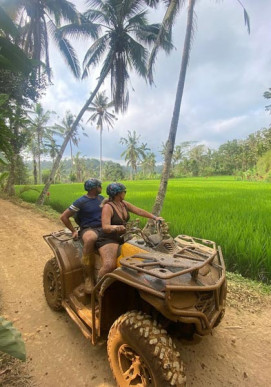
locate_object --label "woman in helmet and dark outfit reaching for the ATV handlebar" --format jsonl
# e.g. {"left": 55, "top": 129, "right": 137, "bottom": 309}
{"left": 96, "top": 183, "right": 163, "bottom": 279}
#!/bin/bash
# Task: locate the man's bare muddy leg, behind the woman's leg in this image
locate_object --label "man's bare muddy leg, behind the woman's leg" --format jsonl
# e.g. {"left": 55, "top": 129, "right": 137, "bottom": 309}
{"left": 82, "top": 230, "right": 98, "bottom": 293}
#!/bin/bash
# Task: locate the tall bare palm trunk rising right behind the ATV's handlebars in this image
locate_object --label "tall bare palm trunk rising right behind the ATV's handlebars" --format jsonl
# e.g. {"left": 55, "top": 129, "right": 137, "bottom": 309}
{"left": 152, "top": 0, "right": 196, "bottom": 216}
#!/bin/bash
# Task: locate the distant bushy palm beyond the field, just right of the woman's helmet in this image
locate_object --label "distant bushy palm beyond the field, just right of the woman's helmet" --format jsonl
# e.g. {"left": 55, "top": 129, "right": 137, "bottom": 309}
{"left": 120, "top": 130, "right": 148, "bottom": 180}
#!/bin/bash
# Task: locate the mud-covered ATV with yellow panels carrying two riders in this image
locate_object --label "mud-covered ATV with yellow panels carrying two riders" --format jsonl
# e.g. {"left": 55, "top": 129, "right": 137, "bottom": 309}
{"left": 43, "top": 223, "right": 226, "bottom": 387}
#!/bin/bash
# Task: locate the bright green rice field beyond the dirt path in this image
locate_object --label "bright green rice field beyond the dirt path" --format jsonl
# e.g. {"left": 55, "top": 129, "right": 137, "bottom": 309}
{"left": 16, "top": 177, "right": 271, "bottom": 283}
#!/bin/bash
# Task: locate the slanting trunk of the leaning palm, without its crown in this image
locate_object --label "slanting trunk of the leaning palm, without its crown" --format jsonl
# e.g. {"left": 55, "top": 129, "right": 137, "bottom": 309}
{"left": 36, "top": 66, "right": 110, "bottom": 205}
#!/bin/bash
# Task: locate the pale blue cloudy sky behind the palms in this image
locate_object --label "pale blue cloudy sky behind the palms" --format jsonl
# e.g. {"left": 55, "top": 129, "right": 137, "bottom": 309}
{"left": 41, "top": 0, "right": 271, "bottom": 163}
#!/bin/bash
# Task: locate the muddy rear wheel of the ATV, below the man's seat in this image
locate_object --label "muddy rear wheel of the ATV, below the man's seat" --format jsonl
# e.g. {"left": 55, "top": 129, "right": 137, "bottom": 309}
{"left": 43, "top": 258, "right": 63, "bottom": 311}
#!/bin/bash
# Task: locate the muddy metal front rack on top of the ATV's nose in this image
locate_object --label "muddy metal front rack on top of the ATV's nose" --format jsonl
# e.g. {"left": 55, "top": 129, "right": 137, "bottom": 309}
{"left": 120, "top": 247, "right": 222, "bottom": 280}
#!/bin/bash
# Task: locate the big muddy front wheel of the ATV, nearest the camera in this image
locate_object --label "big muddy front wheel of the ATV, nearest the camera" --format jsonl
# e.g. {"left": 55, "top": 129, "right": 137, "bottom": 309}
{"left": 107, "top": 311, "right": 186, "bottom": 387}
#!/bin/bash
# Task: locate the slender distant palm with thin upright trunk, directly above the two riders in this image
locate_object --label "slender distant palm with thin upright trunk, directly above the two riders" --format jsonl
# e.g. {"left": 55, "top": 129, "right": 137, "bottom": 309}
{"left": 87, "top": 91, "right": 117, "bottom": 180}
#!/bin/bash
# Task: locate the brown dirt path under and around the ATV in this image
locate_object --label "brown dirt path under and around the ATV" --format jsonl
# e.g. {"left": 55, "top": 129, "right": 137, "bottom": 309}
{"left": 0, "top": 199, "right": 271, "bottom": 387}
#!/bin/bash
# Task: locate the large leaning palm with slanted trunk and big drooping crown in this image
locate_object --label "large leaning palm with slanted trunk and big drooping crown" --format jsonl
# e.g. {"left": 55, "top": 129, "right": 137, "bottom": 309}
{"left": 37, "top": 0, "right": 172, "bottom": 204}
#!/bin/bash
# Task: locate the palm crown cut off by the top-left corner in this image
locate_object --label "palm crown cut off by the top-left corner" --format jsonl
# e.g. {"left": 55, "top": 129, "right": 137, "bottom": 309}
{"left": 2, "top": 0, "right": 83, "bottom": 81}
